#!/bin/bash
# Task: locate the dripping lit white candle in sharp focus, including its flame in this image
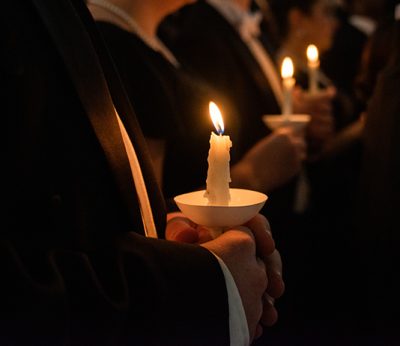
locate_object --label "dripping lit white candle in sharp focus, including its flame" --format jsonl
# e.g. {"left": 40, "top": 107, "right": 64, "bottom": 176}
{"left": 205, "top": 102, "right": 232, "bottom": 205}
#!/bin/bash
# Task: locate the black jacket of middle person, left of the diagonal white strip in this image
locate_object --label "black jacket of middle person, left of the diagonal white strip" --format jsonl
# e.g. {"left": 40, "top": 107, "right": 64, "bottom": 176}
{"left": 160, "top": 1, "right": 280, "bottom": 153}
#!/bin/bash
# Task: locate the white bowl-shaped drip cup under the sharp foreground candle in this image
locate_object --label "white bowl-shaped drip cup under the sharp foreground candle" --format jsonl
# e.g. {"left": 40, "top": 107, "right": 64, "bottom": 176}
{"left": 174, "top": 189, "right": 268, "bottom": 238}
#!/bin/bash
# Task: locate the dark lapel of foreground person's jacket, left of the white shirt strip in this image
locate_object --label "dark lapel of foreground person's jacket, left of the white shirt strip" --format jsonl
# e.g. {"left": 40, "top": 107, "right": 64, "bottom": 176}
{"left": 33, "top": 0, "right": 144, "bottom": 235}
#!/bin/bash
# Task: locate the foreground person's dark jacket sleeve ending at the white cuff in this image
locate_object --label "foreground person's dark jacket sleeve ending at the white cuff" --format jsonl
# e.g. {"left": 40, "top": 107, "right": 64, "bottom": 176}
{"left": 0, "top": 233, "right": 229, "bottom": 346}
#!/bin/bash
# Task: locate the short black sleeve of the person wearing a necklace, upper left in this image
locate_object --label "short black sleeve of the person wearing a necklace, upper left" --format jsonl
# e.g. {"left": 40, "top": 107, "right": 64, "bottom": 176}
{"left": 97, "top": 22, "right": 174, "bottom": 139}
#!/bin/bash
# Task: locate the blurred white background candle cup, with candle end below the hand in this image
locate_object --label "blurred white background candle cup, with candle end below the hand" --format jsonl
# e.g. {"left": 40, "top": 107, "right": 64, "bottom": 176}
{"left": 263, "top": 114, "right": 311, "bottom": 214}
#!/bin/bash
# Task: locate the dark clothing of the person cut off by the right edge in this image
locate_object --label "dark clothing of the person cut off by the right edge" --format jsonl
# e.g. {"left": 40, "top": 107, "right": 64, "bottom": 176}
{"left": 355, "top": 21, "right": 400, "bottom": 344}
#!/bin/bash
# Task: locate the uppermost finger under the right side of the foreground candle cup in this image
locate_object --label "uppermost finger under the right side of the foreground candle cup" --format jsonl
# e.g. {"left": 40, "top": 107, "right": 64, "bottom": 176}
{"left": 246, "top": 214, "right": 275, "bottom": 260}
